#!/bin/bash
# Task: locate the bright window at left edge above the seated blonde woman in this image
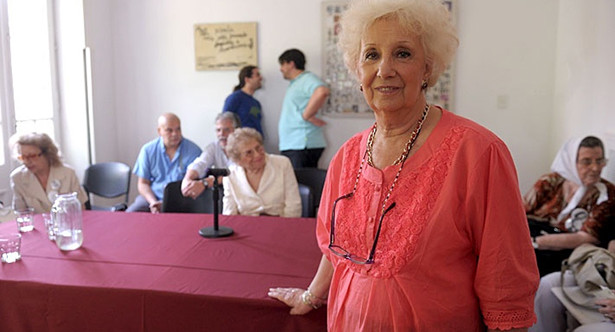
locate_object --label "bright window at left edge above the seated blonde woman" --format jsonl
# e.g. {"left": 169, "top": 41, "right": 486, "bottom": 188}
{"left": 0, "top": 0, "right": 58, "bottom": 203}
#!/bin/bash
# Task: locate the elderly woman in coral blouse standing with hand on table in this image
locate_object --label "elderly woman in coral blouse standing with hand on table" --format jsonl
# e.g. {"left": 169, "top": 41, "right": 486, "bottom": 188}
{"left": 269, "top": 0, "right": 538, "bottom": 332}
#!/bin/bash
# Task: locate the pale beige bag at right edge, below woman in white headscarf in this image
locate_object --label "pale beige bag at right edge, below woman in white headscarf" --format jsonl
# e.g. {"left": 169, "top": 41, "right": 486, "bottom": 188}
{"left": 560, "top": 243, "right": 615, "bottom": 309}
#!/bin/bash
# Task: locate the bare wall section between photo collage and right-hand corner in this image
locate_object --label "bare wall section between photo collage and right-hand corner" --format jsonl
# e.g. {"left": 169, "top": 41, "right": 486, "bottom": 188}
{"left": 455, "top": 0, "right": 558, "bottom": 192}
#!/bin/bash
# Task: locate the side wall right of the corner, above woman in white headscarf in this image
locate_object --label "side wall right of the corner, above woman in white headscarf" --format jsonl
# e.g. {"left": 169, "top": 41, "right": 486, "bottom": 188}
{"left": 551, "top": 0, "right": 615, "bottom": 181}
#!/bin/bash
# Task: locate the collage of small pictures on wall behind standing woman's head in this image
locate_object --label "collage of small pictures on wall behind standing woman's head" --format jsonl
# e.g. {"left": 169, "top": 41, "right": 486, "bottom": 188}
{"left": 321, "top": 0, "right": 456, "bottom": 117}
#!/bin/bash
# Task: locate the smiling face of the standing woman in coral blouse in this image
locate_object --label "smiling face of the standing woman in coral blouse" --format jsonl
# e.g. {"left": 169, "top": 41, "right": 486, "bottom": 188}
{"left": 358, "top": 19, "right": 430, "bottom": 113}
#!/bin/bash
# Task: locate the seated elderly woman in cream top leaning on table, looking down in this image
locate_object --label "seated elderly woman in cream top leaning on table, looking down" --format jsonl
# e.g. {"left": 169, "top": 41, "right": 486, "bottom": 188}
{"left": 223, "top": 128, "right": 301, "bottom": 217}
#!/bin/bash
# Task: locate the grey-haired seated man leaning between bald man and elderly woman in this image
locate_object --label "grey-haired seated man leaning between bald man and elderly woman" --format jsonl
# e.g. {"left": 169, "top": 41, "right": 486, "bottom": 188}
{"left": 182, "top": 112, "right": 240, "bottom": 198}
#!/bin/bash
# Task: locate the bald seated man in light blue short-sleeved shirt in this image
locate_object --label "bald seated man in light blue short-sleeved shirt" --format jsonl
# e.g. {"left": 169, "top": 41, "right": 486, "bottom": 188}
{"left": 126, "top": 113, "right": 201, "bottom": 213}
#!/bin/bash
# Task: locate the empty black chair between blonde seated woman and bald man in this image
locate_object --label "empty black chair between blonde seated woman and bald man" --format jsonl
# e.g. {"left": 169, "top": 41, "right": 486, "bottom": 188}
{"left": 83, "top": 162, "right": 130, "bottom": 211}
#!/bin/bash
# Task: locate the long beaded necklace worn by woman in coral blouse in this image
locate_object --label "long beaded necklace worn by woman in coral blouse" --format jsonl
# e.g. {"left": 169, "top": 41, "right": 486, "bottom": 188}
{"left": 352, "top": 103, "right": 429, "bottom": 214}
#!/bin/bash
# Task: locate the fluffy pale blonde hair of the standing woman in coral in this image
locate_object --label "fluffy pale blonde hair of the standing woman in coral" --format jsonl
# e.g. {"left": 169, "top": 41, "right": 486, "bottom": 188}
{"left": 338, "top": 0, "right": 459, "bottom": 86}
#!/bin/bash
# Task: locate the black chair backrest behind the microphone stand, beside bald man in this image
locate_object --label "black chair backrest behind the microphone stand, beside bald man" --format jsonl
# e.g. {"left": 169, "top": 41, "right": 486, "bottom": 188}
{"left": 162, "top": 180, "right": 224, "bottom": 214}
